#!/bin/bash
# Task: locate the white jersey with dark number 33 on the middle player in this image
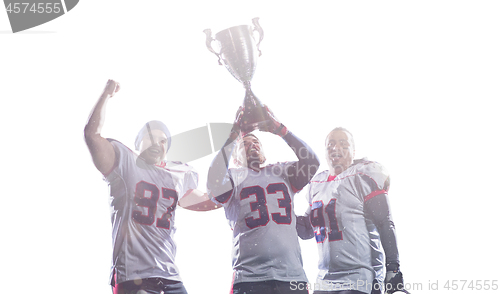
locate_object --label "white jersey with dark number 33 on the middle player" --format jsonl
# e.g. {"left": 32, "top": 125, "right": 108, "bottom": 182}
{"left": 210, "top": 162, "right": 307, "bottom": 284}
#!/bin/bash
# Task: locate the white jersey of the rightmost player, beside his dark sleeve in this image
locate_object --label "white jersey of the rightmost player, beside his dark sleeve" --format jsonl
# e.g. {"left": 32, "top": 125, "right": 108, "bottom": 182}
{"left": 306, "top": 160, "right": 389, "bottom": 293}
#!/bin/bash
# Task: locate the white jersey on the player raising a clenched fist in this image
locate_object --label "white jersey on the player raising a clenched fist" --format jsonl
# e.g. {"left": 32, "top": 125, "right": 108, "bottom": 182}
{"left": 105, "top": 140, "right": 198, "bottom": 283}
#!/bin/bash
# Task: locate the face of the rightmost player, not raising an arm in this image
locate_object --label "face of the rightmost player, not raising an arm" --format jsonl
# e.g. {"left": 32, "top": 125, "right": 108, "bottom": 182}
{"left": 325, "top": 131, "right": 354, "bottom": 175}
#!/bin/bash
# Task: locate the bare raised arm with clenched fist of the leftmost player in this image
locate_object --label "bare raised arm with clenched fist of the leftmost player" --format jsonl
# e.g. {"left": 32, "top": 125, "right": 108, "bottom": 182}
{"left": 84, "top": 80, "right": 120, "bottom": 174}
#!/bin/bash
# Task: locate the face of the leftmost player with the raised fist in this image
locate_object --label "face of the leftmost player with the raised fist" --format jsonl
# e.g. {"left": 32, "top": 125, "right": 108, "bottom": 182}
{"left": 140, "top": 130, "right": 168, "bottom": 164}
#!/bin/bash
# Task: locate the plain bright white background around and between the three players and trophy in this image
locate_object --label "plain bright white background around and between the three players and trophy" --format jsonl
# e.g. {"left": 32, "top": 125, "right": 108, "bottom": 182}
{"left": 0, "top": 0, "right": 500, "bottom": 293}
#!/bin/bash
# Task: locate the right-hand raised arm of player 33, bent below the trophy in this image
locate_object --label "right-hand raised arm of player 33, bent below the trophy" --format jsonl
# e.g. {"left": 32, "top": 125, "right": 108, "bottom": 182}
{"left": 259, "top": 106, "right": 319, "bottom": 191}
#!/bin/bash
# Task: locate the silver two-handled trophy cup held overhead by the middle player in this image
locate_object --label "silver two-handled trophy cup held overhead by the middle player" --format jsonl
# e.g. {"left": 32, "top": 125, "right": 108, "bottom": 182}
{"left": 203, "top": 17, "right": 268, "bottom": 131}
